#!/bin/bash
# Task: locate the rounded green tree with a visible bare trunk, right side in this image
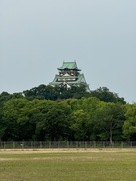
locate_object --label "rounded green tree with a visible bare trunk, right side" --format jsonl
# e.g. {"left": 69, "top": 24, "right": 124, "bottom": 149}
{"left": 94, "top": 103, "right": 125, "bottom": 144}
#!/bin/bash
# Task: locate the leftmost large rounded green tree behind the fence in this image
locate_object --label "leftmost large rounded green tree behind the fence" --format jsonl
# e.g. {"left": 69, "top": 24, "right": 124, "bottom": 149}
{"left": 0, "top": 98, "right": 34, "bottom": 141}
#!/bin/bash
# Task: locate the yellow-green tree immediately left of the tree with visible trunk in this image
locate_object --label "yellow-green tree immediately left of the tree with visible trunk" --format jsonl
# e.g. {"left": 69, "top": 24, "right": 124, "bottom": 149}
{"left": 66, "top": 97, "right": 100, "bottom": 140}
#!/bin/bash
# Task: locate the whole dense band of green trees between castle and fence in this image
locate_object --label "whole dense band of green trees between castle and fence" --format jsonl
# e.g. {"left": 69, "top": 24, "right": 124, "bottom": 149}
{"left": 0, "top": 85, "right": 136, "bottom": 143}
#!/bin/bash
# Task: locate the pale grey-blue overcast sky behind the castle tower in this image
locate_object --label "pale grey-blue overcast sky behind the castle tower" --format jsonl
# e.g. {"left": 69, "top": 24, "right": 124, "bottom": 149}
{"left": 0, "top": 0, "right": 136, "bottom": 103}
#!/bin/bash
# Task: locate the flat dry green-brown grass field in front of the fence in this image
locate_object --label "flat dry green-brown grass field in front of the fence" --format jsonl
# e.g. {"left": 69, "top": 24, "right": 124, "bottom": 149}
{"left": 0, "top": 149, "right": 136, "bottom": 181}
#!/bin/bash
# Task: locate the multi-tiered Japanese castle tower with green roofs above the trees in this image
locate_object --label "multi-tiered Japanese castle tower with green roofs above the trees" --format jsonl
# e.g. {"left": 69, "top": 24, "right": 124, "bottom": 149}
{"left": 49, "top": 61, "right": 90, "bottom": 91}
